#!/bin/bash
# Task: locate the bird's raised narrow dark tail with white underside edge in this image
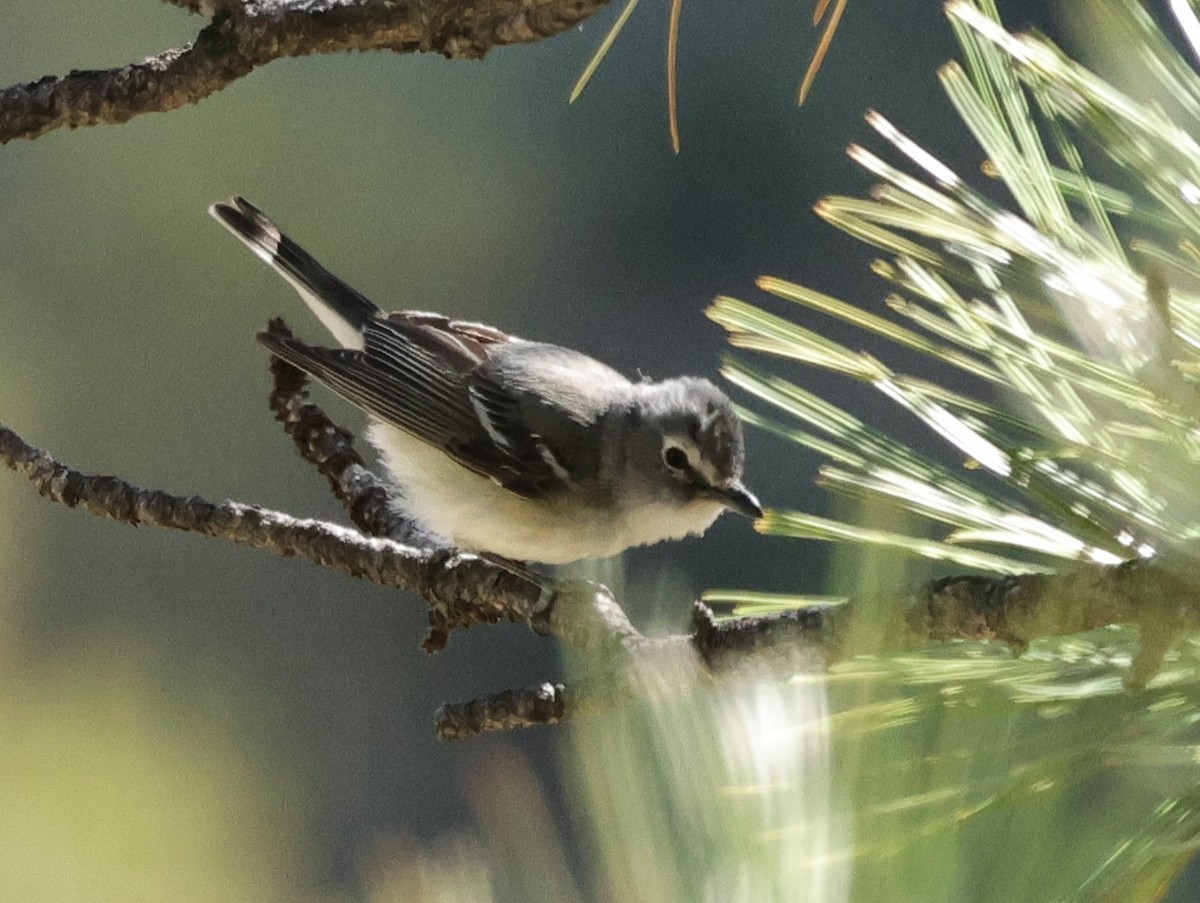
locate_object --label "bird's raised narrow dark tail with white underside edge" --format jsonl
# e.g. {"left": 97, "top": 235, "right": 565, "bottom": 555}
{"left": 209, "top": 197, "right": 379, "bottom": 348}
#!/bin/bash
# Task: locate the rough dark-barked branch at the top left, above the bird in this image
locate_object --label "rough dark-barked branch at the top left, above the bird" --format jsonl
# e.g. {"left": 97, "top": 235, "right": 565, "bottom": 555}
{"left": 0, "top": 0, "right": 607, "bottom": 144}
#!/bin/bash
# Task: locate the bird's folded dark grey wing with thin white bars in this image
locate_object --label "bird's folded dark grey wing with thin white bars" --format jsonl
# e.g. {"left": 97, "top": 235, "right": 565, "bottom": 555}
{"left": 259, "top": 312, "right": 602, "bottom": 497}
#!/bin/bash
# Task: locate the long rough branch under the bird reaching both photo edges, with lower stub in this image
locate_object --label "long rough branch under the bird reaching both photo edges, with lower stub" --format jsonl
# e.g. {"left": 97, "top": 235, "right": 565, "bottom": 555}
{"left": 0, "top": 415, "right": 1200, "bottom": 737}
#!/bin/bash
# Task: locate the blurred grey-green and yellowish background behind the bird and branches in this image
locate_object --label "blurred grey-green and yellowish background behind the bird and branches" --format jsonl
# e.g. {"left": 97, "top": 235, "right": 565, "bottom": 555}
{"left": 0, "top": 0, "right": 1180, "bottom": 901}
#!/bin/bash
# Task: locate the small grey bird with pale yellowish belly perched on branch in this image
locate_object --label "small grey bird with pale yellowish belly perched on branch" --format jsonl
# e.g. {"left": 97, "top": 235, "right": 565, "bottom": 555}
{"left": 209, "top": 197, "right": 763, "bottom": 564}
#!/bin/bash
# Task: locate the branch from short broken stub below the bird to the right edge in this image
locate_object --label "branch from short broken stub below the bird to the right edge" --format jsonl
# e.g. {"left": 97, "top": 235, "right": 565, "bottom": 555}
{"left": 437, "top": 562, "right": 1200, "bottom": 740}
